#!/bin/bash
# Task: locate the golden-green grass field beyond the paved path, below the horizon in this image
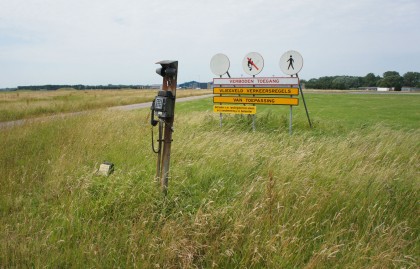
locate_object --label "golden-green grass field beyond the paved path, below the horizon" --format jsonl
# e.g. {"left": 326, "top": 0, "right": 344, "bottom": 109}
{"left": 0, "top": 89, "right": 211, "bottom": 122}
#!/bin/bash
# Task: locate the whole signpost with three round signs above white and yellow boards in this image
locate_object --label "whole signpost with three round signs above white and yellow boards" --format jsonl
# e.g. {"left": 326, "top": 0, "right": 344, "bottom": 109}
{"left": 210, "top": 50, "right": 312, "bottom": 134}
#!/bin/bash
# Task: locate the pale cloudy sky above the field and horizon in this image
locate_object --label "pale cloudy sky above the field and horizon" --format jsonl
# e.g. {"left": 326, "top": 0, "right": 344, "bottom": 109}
{"left": 0, "top": 0, "right": 420, "bottom": 88}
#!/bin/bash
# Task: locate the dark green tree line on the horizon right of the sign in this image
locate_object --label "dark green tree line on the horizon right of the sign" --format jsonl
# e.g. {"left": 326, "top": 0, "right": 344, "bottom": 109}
{"left": 301, "top": 71, "right": 420, "bottom": 91}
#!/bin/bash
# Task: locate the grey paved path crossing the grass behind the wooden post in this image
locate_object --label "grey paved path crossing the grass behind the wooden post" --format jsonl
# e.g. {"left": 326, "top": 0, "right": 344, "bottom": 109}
{"left": 0, "top": 94, "right": 213, "bottom": 129}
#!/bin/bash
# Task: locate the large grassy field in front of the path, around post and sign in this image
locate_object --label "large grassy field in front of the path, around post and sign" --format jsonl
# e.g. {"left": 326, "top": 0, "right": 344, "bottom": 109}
{"left": 0, "top": 91, "right": 420, "bottom": 268}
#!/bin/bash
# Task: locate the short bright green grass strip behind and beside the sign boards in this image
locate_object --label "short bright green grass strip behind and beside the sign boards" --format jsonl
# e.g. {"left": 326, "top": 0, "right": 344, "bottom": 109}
{"left": 182, "top": 92, "right": 420, "bottom": 131}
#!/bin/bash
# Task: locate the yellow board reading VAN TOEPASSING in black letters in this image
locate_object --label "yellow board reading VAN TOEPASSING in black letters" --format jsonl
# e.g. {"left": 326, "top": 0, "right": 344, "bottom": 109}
{"left": 213, "top": 96, "right": 299, "bottom": 106}
